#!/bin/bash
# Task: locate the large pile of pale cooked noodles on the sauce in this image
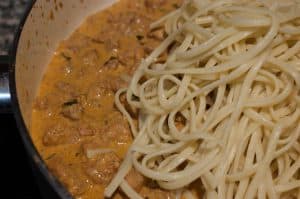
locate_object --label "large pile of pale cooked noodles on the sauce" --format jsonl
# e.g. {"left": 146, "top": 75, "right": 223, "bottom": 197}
{"left": 105, "top": 0, "right": 300, "bottom": 199}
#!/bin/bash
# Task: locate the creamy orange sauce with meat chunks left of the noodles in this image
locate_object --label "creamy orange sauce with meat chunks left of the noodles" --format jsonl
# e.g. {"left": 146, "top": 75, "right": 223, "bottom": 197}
{"left": 31, "top": 0, "right": 181, "bottom": 199}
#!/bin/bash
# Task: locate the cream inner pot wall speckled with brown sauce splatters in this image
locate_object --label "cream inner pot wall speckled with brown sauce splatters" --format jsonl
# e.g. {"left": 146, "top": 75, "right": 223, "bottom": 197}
{"left": 15, "top": 0, "right": 116, "bottom": 129}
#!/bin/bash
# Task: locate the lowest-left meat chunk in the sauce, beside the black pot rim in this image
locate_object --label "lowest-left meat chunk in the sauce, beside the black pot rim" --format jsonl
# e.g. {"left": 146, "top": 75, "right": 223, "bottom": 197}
{"left": 47, "top": 157, "right": 89, "bottom": 196}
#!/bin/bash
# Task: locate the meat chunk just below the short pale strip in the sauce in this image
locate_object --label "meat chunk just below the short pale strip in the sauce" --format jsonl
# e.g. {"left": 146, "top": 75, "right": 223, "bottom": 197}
{"left": 85, "top": 152, "right": 120, "bottom": 185}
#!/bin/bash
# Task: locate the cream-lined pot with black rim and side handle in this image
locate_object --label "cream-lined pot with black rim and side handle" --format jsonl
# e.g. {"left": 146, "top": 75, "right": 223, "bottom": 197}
{"left": 0, "top": 0, "right": 116, "bottom": 199}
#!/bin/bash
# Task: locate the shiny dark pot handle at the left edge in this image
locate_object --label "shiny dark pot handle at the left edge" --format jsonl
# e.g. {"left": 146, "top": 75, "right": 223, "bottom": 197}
{"left": 0, "top": 55, "right": 11, "bottom": 114}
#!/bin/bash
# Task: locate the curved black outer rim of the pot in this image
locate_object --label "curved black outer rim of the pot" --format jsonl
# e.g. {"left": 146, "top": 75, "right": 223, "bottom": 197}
{"left": 9, "top": 0, "right": 72, "bottom": 199}
